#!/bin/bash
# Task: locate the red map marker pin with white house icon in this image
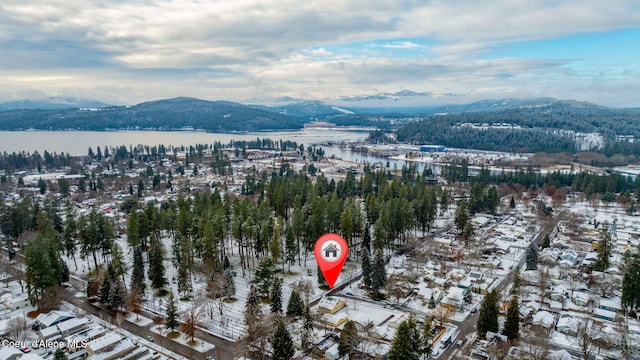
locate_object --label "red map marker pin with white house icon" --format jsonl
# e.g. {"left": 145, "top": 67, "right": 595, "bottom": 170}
{"left": 313, "top": 234, "right": 349, "bottom": 289}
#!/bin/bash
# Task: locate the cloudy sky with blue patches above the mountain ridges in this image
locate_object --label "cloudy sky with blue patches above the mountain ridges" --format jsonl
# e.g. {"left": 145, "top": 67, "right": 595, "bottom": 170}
{"left": 0, "top": 0, "right": 640, "bottom": 106}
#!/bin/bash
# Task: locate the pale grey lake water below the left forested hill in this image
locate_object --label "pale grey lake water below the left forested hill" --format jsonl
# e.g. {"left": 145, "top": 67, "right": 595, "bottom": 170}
{"left": 0, "top": 129, "right": 368, "bottom": 156}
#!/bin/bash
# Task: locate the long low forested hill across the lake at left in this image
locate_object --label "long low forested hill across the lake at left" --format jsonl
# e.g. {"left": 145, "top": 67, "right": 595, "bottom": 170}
{"left": 0, "top": 98, "right": 303, "bottom": 132}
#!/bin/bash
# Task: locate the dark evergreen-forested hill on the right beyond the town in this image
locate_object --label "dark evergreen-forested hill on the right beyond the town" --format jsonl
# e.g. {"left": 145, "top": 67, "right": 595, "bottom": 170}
{"left": 397, "top": 101, "right": 640, "bottom": 156}
